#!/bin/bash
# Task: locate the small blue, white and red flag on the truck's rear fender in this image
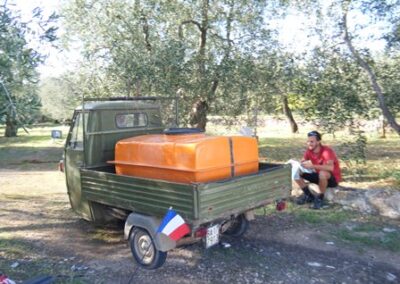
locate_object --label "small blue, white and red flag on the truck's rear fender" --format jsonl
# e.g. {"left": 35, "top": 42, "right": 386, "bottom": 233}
{"left": 157, "top": 208, "right": 190, "bottom": 241}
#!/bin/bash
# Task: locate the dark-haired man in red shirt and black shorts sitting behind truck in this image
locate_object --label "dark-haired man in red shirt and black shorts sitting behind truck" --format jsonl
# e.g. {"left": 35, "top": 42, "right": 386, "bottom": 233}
{"left": 295, "top": 131, "right": 342, "bottom": 209}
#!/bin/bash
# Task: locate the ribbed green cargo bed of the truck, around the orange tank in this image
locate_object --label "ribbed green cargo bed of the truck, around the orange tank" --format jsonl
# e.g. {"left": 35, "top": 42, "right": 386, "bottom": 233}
{"left": 81, "top": 163, "right": 291, "bottom": 225}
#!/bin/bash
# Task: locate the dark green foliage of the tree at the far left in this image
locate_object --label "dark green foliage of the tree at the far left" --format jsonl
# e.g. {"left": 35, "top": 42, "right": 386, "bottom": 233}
{"left": 0, "top": 3, "right": 56, "bottom": 137}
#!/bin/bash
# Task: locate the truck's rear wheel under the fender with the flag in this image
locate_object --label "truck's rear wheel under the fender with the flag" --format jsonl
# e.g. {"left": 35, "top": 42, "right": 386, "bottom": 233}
{"left": 129, "top": 227, "right": 167, "bottom": 269}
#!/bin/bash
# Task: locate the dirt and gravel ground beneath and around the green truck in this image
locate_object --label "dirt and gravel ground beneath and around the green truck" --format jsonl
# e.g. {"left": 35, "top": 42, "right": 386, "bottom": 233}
{"left": 0, "top": 168, "right": 400, "bottom": 283}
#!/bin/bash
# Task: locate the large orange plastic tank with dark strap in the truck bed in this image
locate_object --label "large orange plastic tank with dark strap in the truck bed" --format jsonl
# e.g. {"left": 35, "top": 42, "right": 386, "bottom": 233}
{"left": 110, "top": 133, "right": 258, "bottom": 183}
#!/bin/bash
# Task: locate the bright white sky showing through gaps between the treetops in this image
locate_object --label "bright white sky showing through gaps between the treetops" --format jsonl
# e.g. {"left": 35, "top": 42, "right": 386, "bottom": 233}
{"left": 8, "top": 0, "right": 385, "bottom": 78}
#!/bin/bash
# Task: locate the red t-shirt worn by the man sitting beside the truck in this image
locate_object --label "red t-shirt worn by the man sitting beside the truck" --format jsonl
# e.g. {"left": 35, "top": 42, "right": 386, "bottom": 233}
{"left": 303, "top": 145, "right": 342, "bottom": 182}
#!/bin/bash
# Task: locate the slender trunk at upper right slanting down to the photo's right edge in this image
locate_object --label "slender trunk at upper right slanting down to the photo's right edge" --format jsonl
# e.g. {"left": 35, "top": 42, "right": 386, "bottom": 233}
{"left": 343, "top": 0, "right": 400, "bottom": 135}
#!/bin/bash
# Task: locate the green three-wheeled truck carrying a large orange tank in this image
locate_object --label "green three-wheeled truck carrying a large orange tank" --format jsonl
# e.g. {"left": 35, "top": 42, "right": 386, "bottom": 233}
{"left": 61, "top": 97, "right": 291, "bottom": 269}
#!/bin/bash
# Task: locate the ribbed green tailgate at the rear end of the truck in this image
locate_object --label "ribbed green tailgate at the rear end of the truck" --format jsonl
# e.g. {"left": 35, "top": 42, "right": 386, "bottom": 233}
{"left": 197, "top": 164, "right": 292, "bottom": 223}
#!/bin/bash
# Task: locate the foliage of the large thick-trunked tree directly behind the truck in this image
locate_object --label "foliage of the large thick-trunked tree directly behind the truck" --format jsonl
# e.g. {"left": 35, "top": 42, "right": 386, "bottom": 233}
{"left": 64, "top": 0, "right": 282, "bottom": 129}
